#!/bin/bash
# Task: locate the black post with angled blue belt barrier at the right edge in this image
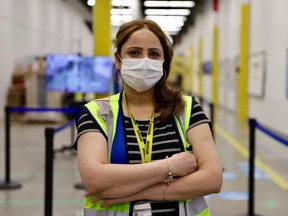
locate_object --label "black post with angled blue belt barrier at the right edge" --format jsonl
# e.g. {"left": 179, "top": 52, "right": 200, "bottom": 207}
{"left": 248, "top": 118, "right": 288, "bottom": 216}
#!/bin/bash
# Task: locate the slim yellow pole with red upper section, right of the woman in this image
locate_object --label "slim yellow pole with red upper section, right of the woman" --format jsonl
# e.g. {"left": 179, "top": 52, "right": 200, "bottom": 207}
{"left": 212, "top": 25, "right": 218, "bottom": 105}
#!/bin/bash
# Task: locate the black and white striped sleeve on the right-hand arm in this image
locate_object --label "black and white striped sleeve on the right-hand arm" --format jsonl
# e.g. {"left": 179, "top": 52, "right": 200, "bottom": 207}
{"left": 188, "top": 98, "right": 211, "bottom": 130}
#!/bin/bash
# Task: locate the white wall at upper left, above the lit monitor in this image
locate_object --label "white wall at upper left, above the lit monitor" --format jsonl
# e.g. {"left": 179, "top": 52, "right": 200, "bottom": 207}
{"left": 0, "top": 0, "right": 93, "bottom": 120}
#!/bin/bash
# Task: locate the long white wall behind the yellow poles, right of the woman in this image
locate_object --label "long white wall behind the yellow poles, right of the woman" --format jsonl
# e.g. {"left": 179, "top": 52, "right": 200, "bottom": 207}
{"left": 175, "top": 0, "right": 288, "bottom": 135}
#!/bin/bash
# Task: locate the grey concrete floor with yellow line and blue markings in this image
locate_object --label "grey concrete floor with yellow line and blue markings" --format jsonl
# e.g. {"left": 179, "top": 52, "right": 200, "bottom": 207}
{"left": 0, "top": 108, "right": 288, "bottom": 216}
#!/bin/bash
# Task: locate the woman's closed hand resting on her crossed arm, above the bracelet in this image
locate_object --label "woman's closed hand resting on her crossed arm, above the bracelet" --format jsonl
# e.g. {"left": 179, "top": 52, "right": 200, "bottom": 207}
{"left": 167, "top": 152, "right": 197, "bottom": 176}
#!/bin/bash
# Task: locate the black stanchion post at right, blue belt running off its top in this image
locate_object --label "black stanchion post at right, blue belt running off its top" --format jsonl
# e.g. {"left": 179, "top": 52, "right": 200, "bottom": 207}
{"left": 248, "top": 118, "right": 256, "bottom": 216}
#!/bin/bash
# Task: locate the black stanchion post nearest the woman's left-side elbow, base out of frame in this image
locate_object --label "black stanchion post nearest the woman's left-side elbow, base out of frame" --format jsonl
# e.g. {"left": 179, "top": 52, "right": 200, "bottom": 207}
{"left": 44, "top": 128, "right": 54, "bottom": 216}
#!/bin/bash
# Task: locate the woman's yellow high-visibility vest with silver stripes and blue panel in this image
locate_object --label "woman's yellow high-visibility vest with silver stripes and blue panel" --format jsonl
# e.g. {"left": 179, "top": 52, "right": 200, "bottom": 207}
{"left": 84, "top": 93, "right": 210, "bottom": 216}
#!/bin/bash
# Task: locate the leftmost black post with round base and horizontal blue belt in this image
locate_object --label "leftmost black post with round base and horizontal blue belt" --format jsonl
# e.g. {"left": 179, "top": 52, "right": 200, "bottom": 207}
{"left": 0, "top": 106, "right": 77, "bottom": 190}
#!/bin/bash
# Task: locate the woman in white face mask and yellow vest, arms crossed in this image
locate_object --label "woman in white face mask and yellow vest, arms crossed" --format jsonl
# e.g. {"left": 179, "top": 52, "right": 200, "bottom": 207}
{"left": 76, "top": 20, "right": 222, "bottom": 216}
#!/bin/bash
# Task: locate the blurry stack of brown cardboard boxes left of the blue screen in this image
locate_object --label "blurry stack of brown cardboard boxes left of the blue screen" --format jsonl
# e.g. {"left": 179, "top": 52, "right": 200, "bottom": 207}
{"left": 6, "top": 58, "right": 65, "bottom": 122}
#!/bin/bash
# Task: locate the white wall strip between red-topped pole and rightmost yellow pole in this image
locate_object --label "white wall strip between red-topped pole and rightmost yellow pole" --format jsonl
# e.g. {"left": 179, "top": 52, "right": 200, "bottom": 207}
{"left": 216, "top": 0, "right": 240, "bottom": 112}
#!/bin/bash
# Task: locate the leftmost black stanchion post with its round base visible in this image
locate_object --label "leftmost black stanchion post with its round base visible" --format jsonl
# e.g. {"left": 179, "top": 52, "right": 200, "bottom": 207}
{"left": 0, "top": 106, "right": 22, "bottom": 190}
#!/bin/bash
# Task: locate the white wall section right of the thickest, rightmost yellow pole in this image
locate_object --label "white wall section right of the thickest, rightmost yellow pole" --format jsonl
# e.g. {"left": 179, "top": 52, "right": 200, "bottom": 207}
{"left": 249, "top": 0, "right": 288, "bottom": 135}
